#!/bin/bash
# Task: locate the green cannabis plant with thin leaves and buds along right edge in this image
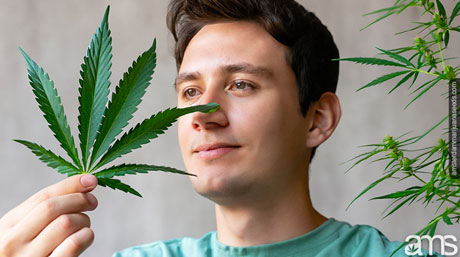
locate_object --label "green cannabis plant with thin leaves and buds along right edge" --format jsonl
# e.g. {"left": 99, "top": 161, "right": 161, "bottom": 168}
{"left": 338, "top": 0, "right": 460, "bottom": 255}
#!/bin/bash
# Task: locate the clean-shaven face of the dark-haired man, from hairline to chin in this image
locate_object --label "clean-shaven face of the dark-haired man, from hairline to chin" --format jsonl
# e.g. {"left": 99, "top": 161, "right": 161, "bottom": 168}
{"left": 176, "top": 22, "right": 309, "bottom": 203}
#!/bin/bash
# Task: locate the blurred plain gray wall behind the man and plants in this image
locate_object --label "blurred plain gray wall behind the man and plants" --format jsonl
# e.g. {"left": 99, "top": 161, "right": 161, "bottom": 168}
{"left": 0, "top": 0, "right": 460, "bottom": 256}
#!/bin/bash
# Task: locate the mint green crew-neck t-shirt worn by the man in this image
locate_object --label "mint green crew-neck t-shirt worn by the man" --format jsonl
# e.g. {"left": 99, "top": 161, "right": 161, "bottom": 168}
{"left": 112, "top": 218, "right": 442, "bottom": 257}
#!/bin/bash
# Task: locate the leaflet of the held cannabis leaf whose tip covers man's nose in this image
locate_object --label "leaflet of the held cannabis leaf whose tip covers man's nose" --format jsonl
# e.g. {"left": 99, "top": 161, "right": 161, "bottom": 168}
{"left": 94, "top": 103, "right": 219, "bottom": 170}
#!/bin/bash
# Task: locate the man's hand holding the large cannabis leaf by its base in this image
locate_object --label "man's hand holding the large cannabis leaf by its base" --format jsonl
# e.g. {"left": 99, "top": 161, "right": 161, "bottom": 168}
{"left": 0, "top": 175, "right": 97, "bottom": 257}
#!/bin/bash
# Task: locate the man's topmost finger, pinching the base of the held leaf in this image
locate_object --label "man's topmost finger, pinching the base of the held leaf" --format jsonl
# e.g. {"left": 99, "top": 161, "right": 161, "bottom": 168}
{"left": 0, "top": 174, "right": 97, "bottom": 228}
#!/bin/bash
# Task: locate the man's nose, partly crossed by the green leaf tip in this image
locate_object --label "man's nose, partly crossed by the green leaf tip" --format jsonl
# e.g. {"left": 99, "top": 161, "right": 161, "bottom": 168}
{"left": 192, "top": 87, "right": 229, "bottom": 131}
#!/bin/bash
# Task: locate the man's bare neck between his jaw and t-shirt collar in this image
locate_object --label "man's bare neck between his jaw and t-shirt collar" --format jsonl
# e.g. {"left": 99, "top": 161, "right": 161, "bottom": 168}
{"left": 216, "top": 182, "right": 327, "bottom": 246}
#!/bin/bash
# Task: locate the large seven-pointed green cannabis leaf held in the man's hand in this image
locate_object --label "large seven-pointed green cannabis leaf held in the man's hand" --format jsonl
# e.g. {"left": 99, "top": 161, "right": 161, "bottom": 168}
{"left": 15, "top": 7, "right": 219, "bottom": 197}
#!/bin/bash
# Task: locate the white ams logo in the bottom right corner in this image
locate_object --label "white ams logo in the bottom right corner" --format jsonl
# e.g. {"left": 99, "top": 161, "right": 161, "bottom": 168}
{"left": 404, "top": 235, "right": 458, "bottom": 256}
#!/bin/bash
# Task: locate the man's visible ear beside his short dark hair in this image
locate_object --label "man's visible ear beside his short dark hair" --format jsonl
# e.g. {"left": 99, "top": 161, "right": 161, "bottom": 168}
{"left": 306, "top": 92, "right": 342, "bottom": 148}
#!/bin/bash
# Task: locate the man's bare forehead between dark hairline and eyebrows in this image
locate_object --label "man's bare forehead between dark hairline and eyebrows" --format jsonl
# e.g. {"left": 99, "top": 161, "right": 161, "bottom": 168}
{"left": 175, "top": 21, "right": 289, "bottom": 89}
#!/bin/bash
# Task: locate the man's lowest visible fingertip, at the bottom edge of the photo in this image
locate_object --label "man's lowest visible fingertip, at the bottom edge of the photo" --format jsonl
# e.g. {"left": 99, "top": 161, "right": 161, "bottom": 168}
{"left": 49, "top": 227, "right": 94, "bottom": 257}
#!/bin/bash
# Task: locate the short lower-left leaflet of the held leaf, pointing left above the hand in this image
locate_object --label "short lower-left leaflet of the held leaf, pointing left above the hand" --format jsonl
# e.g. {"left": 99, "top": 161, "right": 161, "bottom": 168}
{"left": 14, "top": 139, "right": 81, "bottom": 176}
